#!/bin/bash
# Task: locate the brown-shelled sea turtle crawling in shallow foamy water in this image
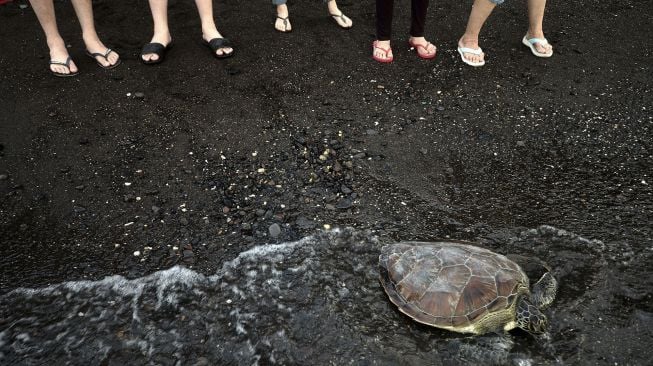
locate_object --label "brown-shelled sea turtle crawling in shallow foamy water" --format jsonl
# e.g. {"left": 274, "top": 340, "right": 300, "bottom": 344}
{"left": 379, "top": 241, "right": 558, "bottom": 334}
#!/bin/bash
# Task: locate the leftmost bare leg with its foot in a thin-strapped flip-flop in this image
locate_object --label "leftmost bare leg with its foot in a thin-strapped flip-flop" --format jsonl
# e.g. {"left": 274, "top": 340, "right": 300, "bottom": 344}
{"left": 30, "top": 0, "right": 78, "bottom": 74}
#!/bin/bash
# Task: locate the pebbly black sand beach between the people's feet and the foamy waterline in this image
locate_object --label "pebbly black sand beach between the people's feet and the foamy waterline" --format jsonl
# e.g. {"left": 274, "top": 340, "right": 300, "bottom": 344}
{"left": 0, "top": 0, "right": 653, "bottom": 362}
